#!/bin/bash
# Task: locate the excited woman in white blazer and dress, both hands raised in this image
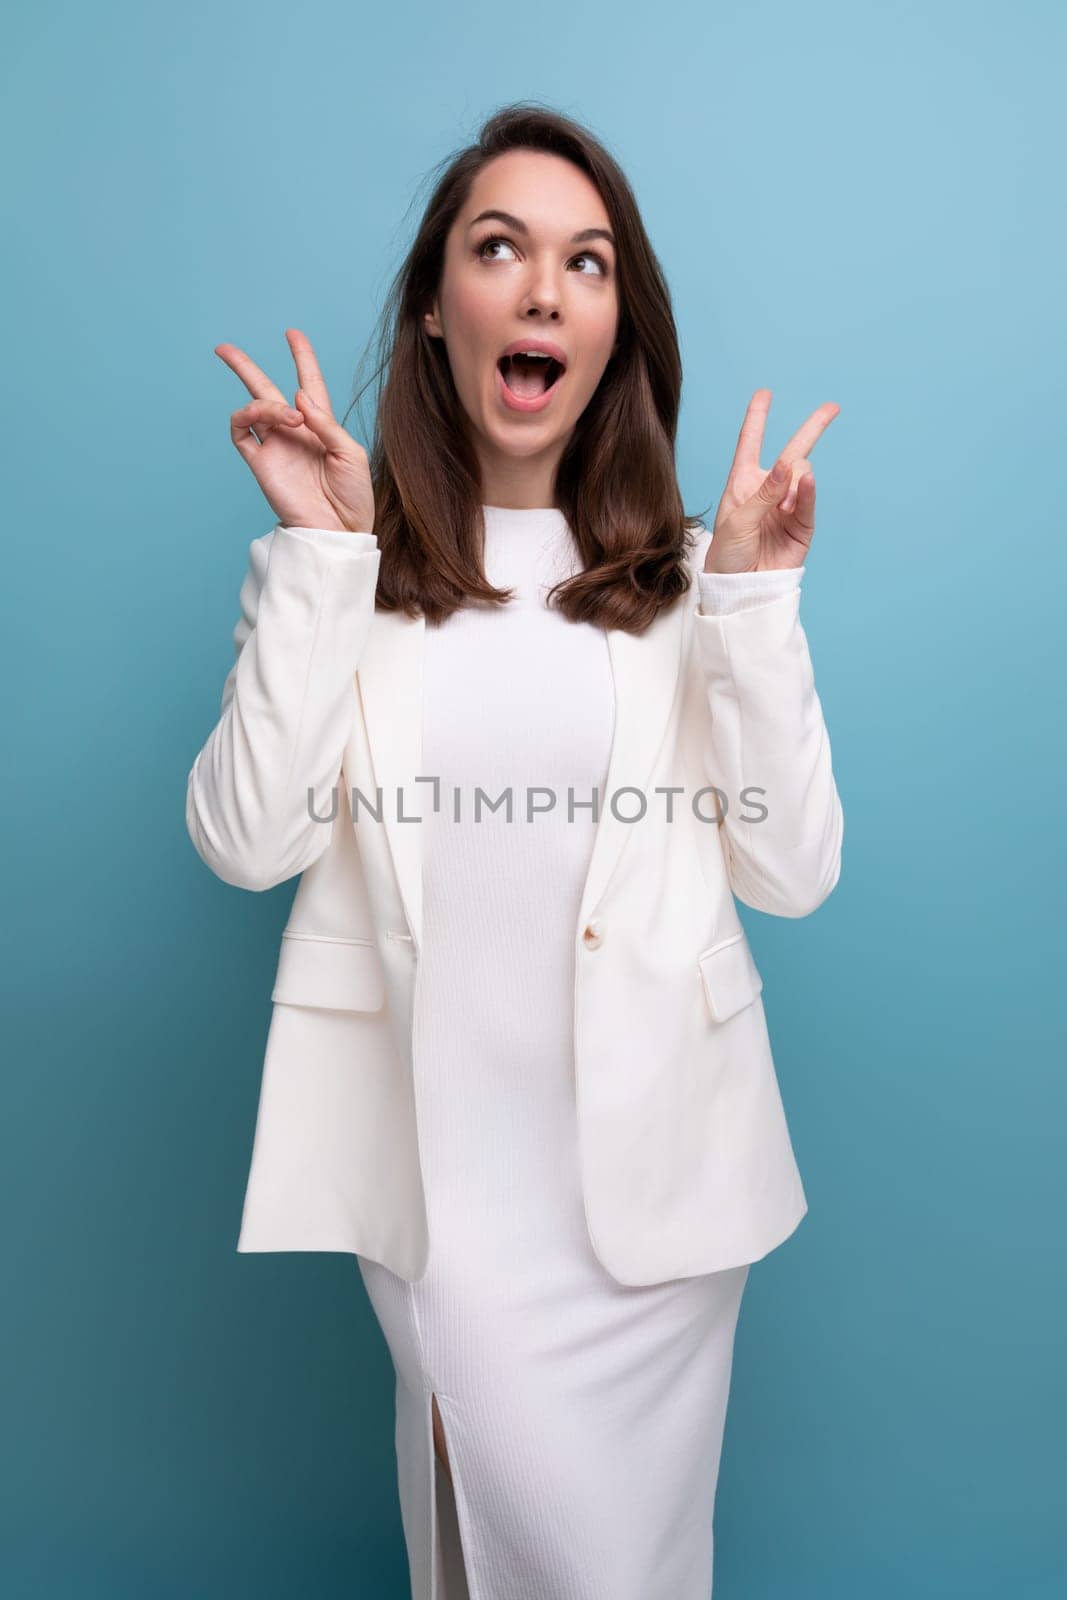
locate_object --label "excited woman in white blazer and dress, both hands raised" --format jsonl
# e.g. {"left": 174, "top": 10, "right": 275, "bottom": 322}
{"left": 187, "top": 106, "right": 841, "bottom": 1600}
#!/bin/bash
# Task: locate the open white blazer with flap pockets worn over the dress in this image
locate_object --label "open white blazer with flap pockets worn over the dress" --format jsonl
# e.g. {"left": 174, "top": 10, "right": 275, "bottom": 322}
{"left": 186, "top": 526, "right": 843, "bottom": 1285}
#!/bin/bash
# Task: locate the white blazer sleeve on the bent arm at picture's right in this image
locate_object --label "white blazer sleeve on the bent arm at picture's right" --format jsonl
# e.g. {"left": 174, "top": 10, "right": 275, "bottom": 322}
{"left": 693, "top": 546, "right": 845, "bottom": 917}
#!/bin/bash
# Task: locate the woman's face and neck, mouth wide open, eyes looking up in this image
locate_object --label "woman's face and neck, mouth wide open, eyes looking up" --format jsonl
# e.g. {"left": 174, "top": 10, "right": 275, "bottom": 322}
{"left": 426, "top": 150, "right": 619, "bottom": 507}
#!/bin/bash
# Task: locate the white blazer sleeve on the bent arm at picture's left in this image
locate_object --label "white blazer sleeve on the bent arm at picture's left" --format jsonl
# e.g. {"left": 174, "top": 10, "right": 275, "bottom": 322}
{"left": 186, "top": 525, "right": 381, "bottom": 890}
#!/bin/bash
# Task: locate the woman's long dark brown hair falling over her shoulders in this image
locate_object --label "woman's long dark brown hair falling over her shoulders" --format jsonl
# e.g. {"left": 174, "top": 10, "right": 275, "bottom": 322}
{"left": 346, "top": 102, "right": 701, "bottom": 634}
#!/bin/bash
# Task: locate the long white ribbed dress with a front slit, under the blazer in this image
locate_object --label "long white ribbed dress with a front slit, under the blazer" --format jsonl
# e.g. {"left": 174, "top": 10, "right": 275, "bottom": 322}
{"left": 358, "top": 506, "right": 777, "bottom": 1600}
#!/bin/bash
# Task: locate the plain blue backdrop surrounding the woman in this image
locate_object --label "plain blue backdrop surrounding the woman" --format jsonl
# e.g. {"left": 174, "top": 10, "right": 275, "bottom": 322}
{"left": 0, "top": 0, "right": 1067, "bottom": 1600}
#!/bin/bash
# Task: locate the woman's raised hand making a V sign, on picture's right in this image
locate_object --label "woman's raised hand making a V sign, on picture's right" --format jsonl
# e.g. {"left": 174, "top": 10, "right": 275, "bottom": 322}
{"left": 704, "top": 389, "right": 841, "bottom": 573}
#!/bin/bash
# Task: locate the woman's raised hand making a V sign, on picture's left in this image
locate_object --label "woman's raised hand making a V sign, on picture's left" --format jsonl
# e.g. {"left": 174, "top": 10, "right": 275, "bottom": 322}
{"left": 214, "top": 328, "right": 374, "bottom": 533}
